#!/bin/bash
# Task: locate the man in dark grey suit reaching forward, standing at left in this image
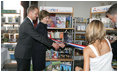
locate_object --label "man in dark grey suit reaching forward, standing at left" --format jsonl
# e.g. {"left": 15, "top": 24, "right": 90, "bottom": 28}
{"left": 15, "top": 6, "right": 59, "bottom": 71}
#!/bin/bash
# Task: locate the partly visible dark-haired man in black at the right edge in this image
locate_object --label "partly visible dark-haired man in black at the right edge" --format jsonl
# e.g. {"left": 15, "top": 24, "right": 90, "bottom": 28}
{"left": 106, "top": 3, "right": 117, "bottom": 61}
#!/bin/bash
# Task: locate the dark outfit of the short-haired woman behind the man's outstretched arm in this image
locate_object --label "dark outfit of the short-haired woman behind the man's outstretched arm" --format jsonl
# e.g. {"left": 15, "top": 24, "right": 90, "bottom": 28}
{"left": 32, "top": 22, "right": 52, "bottom": 71}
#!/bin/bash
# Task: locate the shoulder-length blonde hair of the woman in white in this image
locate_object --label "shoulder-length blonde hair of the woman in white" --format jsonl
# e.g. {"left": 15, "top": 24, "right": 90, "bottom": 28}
{"left": 85, "top": 20, "right": 106, "bottom": 44}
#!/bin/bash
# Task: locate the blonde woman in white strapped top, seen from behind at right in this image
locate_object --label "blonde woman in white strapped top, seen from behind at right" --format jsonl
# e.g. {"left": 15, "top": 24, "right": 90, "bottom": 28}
{"left": 77, "top": 20, "right": 113, "bottom": 71}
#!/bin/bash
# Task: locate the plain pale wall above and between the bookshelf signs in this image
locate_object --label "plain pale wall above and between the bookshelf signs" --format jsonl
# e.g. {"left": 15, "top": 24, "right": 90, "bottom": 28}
{"left": 38, "top": 1, "right": 117, "bottom": 18}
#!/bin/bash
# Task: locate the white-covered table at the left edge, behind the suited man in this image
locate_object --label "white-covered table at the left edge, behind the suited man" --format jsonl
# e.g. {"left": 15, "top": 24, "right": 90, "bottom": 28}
{"left": 1, "top": 48, "right": 10, "bottom": 69}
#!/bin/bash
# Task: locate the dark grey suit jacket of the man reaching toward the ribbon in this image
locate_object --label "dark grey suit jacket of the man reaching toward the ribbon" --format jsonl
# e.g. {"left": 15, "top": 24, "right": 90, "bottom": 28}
{"left": 15, "top": 17, "right": 53, "bottom": 59}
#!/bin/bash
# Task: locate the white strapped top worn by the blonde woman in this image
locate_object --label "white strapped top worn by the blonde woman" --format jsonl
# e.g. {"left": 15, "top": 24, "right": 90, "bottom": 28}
{"left": 89, "top": 39, "right": 113, "bottom": 71}
